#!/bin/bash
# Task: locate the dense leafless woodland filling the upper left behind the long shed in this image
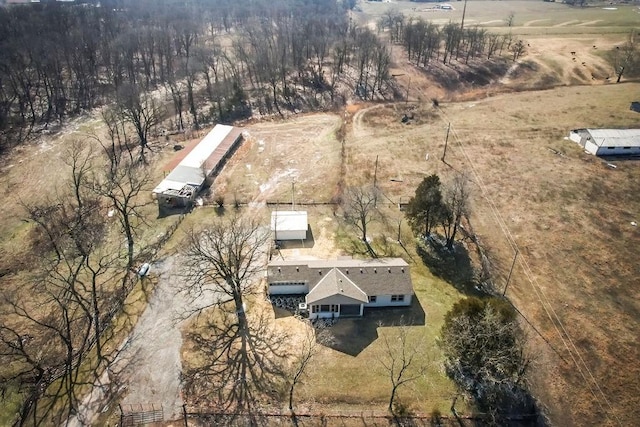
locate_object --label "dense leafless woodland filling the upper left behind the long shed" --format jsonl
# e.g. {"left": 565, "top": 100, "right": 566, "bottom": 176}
{"left": 0, "top": 0, "right": 390, "bottom": 152}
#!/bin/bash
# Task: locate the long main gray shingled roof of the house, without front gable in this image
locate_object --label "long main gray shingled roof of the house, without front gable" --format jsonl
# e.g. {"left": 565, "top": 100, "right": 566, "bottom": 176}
{"left": 267, "top": 258, "right": 413, "bottom": 295}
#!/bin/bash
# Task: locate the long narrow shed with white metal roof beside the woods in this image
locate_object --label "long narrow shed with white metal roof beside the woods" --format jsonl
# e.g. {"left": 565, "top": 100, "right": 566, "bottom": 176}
{"left": 153, "top": 125, "right": 242, "bottom": 209}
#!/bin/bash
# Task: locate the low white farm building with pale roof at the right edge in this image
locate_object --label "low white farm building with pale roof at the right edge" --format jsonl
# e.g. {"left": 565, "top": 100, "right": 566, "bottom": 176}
{"left": 569, "top": 129, "right": 640, "bottom": 156}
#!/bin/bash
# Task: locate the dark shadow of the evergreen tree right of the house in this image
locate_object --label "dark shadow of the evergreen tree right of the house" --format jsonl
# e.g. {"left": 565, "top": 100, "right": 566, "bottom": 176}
{"left": 416, "top": 238, "right": 487, "bottom": 297}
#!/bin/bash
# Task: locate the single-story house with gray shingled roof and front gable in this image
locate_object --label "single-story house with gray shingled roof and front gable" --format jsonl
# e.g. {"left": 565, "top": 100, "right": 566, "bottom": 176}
{"left": 267, "top": 257, "right": 414, "bottom": 319}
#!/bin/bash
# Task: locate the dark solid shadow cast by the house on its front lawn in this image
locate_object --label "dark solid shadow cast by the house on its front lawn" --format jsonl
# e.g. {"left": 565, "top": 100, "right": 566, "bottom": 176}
{"left": 316, "top": 297, "right": 426, "bottom": 356}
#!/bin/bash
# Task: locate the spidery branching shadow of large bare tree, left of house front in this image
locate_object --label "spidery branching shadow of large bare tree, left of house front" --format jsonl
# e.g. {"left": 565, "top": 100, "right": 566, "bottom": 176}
{"left": 183, "top": 306, "right": 289, "bottom": 417}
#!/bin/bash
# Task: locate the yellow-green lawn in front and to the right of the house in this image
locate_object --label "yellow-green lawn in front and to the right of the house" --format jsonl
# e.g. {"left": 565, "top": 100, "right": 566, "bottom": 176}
{"left": 299, "top": 222, "right": 470, "bottom": 414}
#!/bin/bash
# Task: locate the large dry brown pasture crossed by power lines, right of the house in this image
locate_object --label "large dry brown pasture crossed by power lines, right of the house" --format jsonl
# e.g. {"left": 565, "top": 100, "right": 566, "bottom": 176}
{"left": 348, "top": 84, "right": 640, "bottom": 425}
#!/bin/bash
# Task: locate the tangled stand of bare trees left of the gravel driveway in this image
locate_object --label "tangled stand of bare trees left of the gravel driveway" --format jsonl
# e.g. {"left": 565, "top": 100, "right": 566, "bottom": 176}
{"left": 0, "top": 141, "right": 150, "bottom": 425}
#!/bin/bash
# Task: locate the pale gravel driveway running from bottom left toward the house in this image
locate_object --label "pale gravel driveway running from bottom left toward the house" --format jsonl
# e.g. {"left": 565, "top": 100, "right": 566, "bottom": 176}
{"left": 68, "top": 255, "right": 211, "bottom": 427}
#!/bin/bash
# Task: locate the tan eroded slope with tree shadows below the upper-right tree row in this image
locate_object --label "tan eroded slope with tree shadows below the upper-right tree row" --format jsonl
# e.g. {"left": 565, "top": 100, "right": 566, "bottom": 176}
{"left": 391, "top": 38, "right": 615, "bottom": 105}
